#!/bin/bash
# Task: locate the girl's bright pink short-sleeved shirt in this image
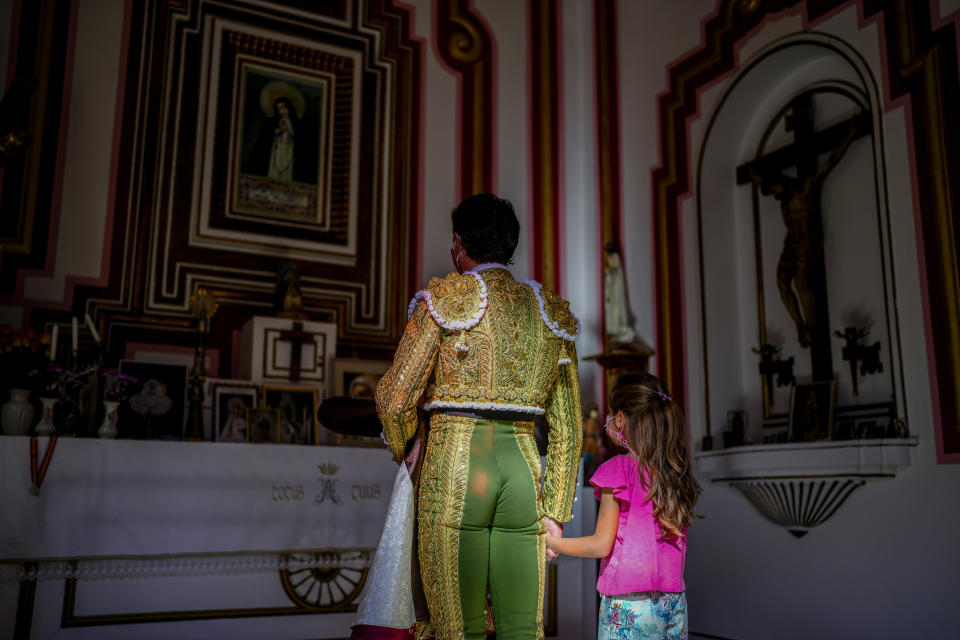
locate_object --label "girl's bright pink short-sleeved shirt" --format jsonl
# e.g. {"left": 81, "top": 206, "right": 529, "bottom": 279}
{"left": 590, "top": 455, "right": 687, "bottom": 596}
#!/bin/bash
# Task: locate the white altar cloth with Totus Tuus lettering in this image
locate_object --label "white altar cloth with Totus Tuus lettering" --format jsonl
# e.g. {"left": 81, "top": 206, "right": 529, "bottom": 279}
{"left": 0, "top": 436, "right": 397, "bottom": 559}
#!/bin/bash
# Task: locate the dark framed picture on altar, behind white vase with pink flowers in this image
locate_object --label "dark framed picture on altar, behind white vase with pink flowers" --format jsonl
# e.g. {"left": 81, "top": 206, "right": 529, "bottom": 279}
{"left": 117, "top": 360, "right": 187, "bottom": 440}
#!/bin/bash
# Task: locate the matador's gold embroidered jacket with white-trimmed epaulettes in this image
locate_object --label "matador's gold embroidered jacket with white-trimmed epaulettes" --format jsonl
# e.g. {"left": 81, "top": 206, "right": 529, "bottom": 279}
{"left": 376, "top": 268, "right": 583, "bottom": 522}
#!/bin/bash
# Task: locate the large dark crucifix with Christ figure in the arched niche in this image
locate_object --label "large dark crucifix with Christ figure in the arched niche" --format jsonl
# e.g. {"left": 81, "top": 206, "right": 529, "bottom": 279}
{"left": 737, "top": 92, "right": 871, "bottom": 382}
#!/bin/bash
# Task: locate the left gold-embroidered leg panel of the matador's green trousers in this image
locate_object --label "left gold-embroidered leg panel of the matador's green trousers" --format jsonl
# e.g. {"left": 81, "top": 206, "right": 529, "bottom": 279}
{"left": 418, "top": 414, "right": 476, "bottom": 640}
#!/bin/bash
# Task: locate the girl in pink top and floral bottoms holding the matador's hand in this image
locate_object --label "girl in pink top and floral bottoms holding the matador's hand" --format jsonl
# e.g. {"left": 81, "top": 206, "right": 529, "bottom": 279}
{"left": 547, "top": 373, "right": 700, "bottom": 640}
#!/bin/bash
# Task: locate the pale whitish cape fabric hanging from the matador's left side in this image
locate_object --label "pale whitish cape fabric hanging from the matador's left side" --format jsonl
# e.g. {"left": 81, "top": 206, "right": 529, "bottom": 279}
{"left": 353, "top": 464, "right": 416, "bottom": 629}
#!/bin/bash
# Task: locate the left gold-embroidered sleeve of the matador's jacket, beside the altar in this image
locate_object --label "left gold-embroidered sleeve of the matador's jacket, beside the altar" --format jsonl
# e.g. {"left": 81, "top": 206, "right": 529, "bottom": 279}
{"left": 376, "top": 302, "right": 440, "bottom": 462}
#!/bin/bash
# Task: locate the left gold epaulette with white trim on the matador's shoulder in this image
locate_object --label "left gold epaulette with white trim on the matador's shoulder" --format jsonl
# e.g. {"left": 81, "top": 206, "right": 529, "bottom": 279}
{"left": 407, "top": 273, "right": 487, "bottom": 331}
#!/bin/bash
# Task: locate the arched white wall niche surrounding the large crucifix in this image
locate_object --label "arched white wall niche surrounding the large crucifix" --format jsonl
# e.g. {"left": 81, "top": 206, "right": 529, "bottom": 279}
{"left": 689, "top": 32, "right": 906, "bottom": 446}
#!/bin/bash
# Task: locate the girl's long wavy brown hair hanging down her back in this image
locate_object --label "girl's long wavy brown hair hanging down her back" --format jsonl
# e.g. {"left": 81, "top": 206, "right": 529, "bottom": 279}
{"left": 610, "top": 373, "right": 701, "bottom": 538}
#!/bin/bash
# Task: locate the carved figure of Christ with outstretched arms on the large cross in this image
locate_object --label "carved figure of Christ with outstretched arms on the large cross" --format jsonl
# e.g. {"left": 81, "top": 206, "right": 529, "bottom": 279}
{"left": 747, "top": 116, "right": 862, "bottom": 347}
